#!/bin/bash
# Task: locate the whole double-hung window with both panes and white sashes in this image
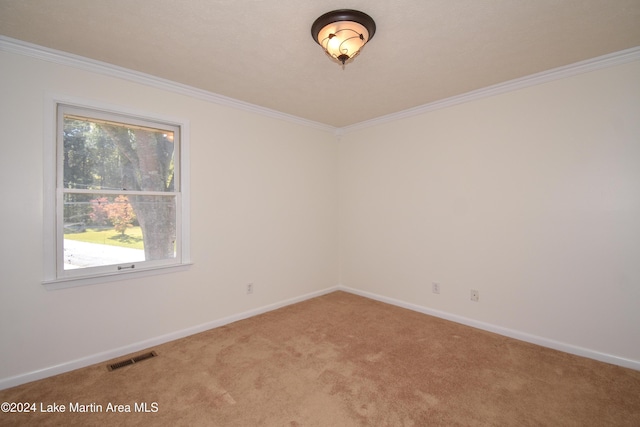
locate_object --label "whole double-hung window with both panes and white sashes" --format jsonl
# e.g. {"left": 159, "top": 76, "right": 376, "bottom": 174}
{"left": 45, "top": 104, "right": 188, "bottom": 287}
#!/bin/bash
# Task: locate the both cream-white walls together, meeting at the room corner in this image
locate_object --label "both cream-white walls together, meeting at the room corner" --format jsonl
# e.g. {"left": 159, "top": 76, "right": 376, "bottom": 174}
{"left": 0, "top": 42, "right": 640, "bottom": 388}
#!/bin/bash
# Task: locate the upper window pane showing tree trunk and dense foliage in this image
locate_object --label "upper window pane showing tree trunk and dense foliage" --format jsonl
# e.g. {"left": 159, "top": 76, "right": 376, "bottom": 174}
{"left": 63, "top": 114, "right": 175, "bottom": 192}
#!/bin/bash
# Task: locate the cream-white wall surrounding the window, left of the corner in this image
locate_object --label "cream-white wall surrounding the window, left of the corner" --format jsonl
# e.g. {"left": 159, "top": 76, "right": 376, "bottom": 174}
{"left": 0, "top": 50, "right": 338, "bottom": 388}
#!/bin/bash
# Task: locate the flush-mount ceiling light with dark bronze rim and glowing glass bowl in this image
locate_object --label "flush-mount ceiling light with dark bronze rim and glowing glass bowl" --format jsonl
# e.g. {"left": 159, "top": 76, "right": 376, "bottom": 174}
{"left": 311, "top": 9, "right": 376, "bottom": 69}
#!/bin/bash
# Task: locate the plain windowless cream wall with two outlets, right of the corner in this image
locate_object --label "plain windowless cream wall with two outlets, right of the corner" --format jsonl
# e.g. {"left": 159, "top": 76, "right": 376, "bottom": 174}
{"left": 340, "top": 61, "right": 640, "bottom": 367}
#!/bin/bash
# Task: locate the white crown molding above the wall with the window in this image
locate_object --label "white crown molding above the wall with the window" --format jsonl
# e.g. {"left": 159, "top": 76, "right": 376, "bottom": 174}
{"left": 0, "top": 35, "right": 336, "bottom": 133}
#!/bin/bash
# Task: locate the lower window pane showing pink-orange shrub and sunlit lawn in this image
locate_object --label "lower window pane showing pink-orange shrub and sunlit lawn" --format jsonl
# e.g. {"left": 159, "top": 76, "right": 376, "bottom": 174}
{"left": 63, "top": 193, "right": 176, "bottom": 270}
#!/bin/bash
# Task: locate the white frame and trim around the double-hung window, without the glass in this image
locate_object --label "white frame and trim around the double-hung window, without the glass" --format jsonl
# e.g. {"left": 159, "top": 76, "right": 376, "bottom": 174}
{"left": 43, "top": 97, "right": 191, "bottom": 290}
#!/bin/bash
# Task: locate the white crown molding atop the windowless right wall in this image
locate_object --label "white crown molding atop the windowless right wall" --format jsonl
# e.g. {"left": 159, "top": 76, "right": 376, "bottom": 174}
{"left": 336, "top": 46, "right": 640, "bottom": 136}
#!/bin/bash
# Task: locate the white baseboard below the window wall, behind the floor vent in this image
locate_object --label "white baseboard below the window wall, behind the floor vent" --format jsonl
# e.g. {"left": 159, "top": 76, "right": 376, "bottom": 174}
{"left": 0, "top": 286, "right": 338, "bottom": 390}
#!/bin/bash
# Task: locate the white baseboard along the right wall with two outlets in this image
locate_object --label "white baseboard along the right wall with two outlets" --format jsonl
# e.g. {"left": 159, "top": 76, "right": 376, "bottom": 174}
{"left": 337, "top": 285, "right": 640, "bottom": 371}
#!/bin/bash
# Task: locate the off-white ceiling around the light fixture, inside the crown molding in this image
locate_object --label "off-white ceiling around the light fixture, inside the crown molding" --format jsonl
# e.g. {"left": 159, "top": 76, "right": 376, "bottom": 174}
{"left": 0, "top": 0, "right": 640, "bottom": 127}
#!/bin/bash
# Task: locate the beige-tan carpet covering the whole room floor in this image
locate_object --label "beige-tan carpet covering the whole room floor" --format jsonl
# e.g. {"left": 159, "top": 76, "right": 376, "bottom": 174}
{"left": 0, "top": 292, "right": 640, "bottom": 426}
